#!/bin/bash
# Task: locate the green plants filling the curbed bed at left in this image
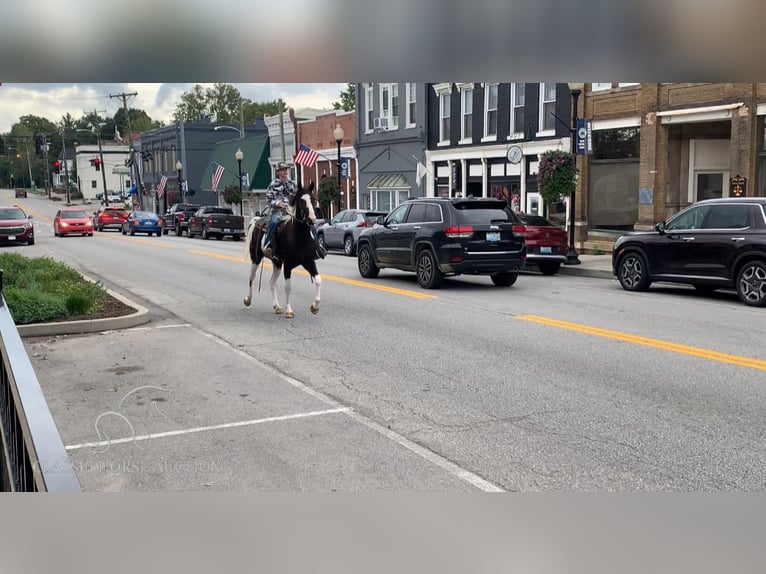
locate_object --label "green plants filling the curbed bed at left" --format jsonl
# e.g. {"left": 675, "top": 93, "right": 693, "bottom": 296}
{"left": 0, "top": 253, "right": 106, "bottom": 325}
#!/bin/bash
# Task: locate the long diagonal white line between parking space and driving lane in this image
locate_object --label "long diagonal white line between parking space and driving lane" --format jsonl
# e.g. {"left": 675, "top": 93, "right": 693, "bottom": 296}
{"left": 198, "top": 327, "right": 505, "bottom": 492}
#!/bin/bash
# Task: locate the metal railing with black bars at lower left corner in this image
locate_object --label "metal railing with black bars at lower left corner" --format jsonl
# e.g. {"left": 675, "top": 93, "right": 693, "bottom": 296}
{"left": 0, "top": 270, "right": 81, "bottom": 492}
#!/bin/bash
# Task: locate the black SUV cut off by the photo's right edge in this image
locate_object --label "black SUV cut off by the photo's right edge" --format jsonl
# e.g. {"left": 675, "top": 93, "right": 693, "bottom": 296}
{"left": 612, "top": 197, "right": 766, "bottom": 307}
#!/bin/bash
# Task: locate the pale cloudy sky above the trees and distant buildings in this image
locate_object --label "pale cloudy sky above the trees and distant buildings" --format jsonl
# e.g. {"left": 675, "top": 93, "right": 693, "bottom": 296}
{"left": 0, "top": 82, "right": 346, "bottom": 134}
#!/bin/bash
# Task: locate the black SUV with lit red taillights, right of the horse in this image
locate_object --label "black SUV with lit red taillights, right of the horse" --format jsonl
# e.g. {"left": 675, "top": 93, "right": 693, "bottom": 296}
{"left": 357, "top": 197, "right": 526, "bottom": 289}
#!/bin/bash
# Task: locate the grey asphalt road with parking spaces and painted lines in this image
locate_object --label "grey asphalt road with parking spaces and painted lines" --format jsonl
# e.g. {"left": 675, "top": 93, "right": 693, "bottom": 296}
{"left": 10, "top": 192, "right": 766, "bottom": 492}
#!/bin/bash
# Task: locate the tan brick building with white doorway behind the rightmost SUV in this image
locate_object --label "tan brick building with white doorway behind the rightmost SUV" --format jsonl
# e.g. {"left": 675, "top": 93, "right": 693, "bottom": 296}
{"left": 576, "top": 83, "right": 766, "bottom": 249}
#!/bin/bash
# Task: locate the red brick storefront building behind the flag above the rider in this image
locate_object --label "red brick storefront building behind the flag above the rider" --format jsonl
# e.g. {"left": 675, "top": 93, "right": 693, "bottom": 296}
{"left": 297, "top": 111, "right": 357, "bottom": 217}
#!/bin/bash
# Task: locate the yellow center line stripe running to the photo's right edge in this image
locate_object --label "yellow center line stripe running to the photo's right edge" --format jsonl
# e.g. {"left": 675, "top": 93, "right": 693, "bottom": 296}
{"left": 514, "top": 315, "right": 766, "bottom": 371}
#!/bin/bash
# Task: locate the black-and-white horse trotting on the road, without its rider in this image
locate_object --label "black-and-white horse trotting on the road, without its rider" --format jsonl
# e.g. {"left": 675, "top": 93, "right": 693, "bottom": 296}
{"left": 244, "top": 182, "right": 322, "bottom": 319}
